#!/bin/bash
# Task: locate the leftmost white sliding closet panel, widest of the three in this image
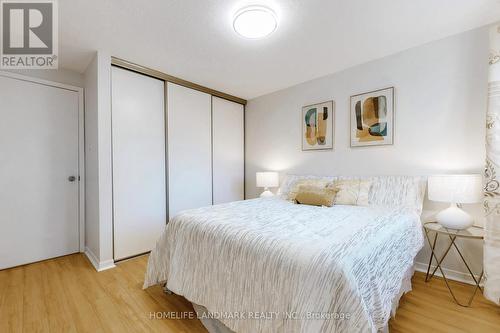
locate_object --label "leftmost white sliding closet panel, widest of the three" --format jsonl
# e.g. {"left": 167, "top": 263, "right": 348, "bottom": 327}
{"left": 111, "top": 67, "right": 167, "bottom": 260}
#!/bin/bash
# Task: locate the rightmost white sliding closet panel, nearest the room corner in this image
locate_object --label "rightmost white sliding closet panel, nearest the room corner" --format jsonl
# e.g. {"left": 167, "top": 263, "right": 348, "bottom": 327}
{"left": 212, "top": 97, "right": 245, "bottom": 204}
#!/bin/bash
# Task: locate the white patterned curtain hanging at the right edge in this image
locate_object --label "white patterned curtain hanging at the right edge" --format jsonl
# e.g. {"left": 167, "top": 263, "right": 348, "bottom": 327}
{"left": 484, "top": 24, "right": 500, "bottom": 304}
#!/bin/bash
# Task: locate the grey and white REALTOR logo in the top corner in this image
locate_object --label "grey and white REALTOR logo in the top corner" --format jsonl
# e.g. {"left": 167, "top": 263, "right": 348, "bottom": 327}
{"left": 0, "top": 0, "right": 58, "bottom": 69}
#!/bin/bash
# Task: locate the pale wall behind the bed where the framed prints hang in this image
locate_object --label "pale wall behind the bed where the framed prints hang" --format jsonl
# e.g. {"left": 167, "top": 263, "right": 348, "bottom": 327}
{"left": 245, "top": 28, "right": 488, "bottom": 282}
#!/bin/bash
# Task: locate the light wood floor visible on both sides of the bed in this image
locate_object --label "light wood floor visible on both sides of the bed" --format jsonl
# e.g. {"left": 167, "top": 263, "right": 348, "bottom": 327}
{"left": 0, "top": 254, "right": 500, "bottom": 333}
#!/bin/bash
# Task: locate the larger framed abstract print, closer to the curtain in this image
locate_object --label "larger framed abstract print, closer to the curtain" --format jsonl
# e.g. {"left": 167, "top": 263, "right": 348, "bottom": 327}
{"left": 351, "top": 87, "right": 394, "bottom": 147}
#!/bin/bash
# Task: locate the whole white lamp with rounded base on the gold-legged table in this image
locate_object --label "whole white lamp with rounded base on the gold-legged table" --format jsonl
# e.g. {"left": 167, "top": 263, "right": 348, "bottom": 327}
{"left": 428, "top": 174, "right": 483, "bottom": 230}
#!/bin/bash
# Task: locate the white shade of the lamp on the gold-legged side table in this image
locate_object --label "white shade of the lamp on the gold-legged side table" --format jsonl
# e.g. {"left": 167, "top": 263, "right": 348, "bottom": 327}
{"left": 428, "top": 174, "right": 483, "bottom": 203}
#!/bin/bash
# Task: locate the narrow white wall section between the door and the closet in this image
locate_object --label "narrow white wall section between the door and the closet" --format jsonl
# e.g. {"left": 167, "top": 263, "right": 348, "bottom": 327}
{"left": 84, "top": 51, "right": 114, "bottom": 270}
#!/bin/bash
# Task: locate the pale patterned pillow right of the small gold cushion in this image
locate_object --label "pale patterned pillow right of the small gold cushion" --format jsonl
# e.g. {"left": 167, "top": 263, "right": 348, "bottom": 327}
{"left": 328, "top": 180, "right": 372, "bottom": 206}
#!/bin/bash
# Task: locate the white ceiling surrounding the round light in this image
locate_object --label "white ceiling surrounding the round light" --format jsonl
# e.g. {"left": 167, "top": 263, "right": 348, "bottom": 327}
{"left": 59, "top": 0, "right": 500, "bottom": 99}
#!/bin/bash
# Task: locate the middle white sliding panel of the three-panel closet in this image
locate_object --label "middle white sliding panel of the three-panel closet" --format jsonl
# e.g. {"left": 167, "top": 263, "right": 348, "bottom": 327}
{"left": 167, "top": 82, "right": 212, "bottom": 218}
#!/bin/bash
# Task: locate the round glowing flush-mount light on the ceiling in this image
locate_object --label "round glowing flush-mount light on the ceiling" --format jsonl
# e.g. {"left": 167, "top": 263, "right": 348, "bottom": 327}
{"left": 233, "top": 6, "right": 278, "bottom": 39}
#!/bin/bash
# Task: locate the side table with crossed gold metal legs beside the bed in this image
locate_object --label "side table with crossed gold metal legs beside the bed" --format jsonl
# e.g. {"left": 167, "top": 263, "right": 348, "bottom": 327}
{"left": 424, "top": 222, "right": 484, "bottom": 307}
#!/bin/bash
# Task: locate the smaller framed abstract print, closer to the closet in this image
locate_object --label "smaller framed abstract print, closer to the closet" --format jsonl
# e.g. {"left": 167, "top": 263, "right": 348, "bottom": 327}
{"left": 302, "top": 101, "right": 335, "bottom": 150}
